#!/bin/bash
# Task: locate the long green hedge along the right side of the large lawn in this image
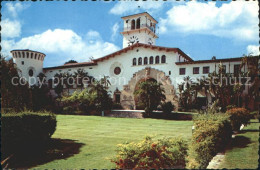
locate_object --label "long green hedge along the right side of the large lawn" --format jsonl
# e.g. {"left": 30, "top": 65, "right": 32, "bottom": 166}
{"left": 187, "top": 114, "right": 232, "bottom": 169}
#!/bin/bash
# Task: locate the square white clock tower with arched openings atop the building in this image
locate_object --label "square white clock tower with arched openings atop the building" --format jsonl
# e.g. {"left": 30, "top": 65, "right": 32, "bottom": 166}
{"left": 121, "top": 12, "right": 158, "bottom": 48}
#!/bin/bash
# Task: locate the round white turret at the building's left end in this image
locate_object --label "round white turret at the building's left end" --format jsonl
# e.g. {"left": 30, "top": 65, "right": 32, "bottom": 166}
{"left": 11, "top": 49, "right": 46, "bottom": 85}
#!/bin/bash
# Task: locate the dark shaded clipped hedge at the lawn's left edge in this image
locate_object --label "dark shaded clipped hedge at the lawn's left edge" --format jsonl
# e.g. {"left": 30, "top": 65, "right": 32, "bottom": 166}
{"left": 1, "top": 111, "right": 57, "bottom": 157}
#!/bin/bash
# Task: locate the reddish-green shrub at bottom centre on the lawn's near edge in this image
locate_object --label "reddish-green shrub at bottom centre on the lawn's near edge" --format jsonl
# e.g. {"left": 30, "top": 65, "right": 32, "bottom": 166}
{"left": 111, "top": 137, "right": 187, "bottom": 169}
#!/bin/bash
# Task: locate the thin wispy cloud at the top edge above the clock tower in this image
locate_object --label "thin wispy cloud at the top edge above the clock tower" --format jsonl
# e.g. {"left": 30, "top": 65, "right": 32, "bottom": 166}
{"left": 109, "top": 0, "right": 165, "bottom": 15}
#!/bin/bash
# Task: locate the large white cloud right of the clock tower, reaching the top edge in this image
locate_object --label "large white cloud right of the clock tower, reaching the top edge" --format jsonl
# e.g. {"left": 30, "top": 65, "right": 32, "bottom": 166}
{"left": 160, "top": 1, "right": 259, "bottom": 41}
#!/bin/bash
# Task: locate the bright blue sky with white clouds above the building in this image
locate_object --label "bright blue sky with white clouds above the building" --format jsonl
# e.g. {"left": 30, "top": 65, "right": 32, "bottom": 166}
{"left": 1, "top": 0, "right": 259, "bottom": 67}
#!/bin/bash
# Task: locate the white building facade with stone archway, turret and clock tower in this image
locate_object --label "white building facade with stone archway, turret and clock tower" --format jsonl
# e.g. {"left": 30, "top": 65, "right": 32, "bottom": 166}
{"left": 11, "top": 12, "right": 250, "bottom": 109}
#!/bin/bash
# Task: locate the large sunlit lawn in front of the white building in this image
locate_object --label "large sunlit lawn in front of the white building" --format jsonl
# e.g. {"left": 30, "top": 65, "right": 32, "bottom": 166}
{"left": 35, "top": 115, "right": 193, "bottom": 169}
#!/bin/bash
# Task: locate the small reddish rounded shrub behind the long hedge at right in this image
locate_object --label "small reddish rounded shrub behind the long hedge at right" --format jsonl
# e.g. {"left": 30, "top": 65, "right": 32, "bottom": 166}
{"left": 226, "top": 108, "right": 250, "bottom": 131}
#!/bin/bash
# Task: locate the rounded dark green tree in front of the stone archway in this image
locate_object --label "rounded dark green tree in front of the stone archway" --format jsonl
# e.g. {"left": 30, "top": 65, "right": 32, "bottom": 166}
{"left": 134, "top": 80, "right": 165, "bottom": 116}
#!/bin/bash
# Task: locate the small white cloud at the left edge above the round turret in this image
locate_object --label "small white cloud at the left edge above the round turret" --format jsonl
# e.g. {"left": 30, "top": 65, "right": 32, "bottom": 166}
{"left": 1, "top": 19, "right": 21, "bottom": 38}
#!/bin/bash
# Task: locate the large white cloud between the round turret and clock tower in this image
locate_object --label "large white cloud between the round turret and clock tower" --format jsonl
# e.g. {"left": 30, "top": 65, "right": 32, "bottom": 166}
{"left": 2, "top": 29, "right": 119, "bottom": 65}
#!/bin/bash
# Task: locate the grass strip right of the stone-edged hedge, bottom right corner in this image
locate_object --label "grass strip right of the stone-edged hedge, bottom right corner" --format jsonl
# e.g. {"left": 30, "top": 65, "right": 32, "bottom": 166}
{"left": 219, "top": 119, "right": 260, "bottom": 169}
